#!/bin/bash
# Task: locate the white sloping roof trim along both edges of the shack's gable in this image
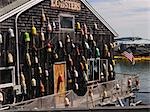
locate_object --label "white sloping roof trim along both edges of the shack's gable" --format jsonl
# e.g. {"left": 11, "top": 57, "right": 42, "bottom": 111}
{"left": 0, "top": 0, "right": 118, "bottom": 37}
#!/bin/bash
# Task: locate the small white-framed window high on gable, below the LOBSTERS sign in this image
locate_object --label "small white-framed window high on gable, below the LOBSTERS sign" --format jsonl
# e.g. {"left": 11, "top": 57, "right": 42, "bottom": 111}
{"left": 59, "top": 14, "right": 74, "bottom": 30}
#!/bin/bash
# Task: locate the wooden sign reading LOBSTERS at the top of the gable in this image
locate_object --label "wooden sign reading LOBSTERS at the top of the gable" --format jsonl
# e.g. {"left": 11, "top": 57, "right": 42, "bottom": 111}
{"left": 51, "top": 0, "right": 81, "bottom": 11}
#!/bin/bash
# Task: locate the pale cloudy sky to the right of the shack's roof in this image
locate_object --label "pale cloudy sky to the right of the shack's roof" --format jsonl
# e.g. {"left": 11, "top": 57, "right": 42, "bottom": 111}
{"left": 87, "top": 0, "right": 150, "bottom": 39}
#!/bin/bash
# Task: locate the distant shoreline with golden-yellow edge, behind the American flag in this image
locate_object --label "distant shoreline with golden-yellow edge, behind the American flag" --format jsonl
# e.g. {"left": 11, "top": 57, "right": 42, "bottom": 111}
{"left": 114, "top": 37, "right": 150, "bottom": 61}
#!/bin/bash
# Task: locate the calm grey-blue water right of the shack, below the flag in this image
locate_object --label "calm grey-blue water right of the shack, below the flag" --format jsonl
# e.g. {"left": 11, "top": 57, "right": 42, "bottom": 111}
{"left": 115, "top": 62, "right": 150, "bottom": 104}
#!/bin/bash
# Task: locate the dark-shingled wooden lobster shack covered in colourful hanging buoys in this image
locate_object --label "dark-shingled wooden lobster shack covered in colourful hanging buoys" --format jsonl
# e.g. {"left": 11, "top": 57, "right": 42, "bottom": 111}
{"left": 0, "top": 0, "right": 118, "bottom": 102}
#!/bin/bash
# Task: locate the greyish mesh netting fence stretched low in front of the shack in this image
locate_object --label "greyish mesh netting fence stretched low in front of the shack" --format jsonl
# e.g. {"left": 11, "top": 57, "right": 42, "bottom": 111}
{"left": 2, "top": 75, "right": 141, "bottom": 110}
